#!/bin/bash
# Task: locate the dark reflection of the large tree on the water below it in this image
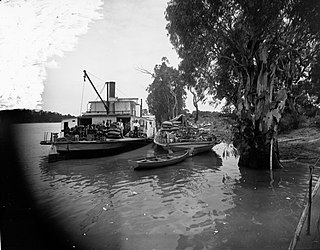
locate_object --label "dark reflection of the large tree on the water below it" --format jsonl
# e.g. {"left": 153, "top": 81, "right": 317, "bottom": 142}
{"left": 205, "top": 164, "right": 303, "bottom": 249}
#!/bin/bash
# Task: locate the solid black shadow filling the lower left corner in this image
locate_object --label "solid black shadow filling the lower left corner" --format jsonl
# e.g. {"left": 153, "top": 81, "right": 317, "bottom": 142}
{"left": 0, "top": 119, "right": 78, "bottom": 249}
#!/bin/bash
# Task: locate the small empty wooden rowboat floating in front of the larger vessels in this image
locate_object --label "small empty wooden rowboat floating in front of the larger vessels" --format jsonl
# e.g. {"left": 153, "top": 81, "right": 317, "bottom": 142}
{"left": 131, "top": 151, "right": 189, "bottom": 170}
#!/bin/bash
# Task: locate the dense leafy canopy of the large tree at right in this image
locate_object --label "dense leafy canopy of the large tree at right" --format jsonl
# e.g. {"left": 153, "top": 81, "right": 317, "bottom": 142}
{"left": 166, "top": 0, "right": 320, "bottom": 109}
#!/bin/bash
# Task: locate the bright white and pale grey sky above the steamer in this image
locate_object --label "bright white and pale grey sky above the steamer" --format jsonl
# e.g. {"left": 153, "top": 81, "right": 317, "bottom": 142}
{"left": 0, "top": 0, "right": 213, "bottom": 115}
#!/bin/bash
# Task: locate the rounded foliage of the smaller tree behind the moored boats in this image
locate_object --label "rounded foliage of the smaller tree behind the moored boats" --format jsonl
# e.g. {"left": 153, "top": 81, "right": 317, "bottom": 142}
{"left": 147, "top": 58, "right": 186, "bottom": 123}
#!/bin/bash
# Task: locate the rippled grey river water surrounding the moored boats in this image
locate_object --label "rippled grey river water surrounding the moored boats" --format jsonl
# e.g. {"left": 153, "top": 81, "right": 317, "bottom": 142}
{"left": 11, "top": 123, "right": 318, "bottom": 250}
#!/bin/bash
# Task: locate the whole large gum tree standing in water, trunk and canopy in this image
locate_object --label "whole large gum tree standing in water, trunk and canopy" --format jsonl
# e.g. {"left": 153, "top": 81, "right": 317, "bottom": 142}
{"left": 166, "top": 0, "right": 320, "bottom": 168}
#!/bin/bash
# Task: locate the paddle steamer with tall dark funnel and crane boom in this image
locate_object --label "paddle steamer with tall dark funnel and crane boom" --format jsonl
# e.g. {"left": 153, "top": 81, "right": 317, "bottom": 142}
{"left": 40, "top": 71, "right": 156, "bottom": 161}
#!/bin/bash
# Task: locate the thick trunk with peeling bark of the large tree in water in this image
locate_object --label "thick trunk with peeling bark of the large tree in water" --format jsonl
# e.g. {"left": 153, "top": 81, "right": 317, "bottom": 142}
{"left": 234, "top": 44, "right": 287, "bottom": 169}
